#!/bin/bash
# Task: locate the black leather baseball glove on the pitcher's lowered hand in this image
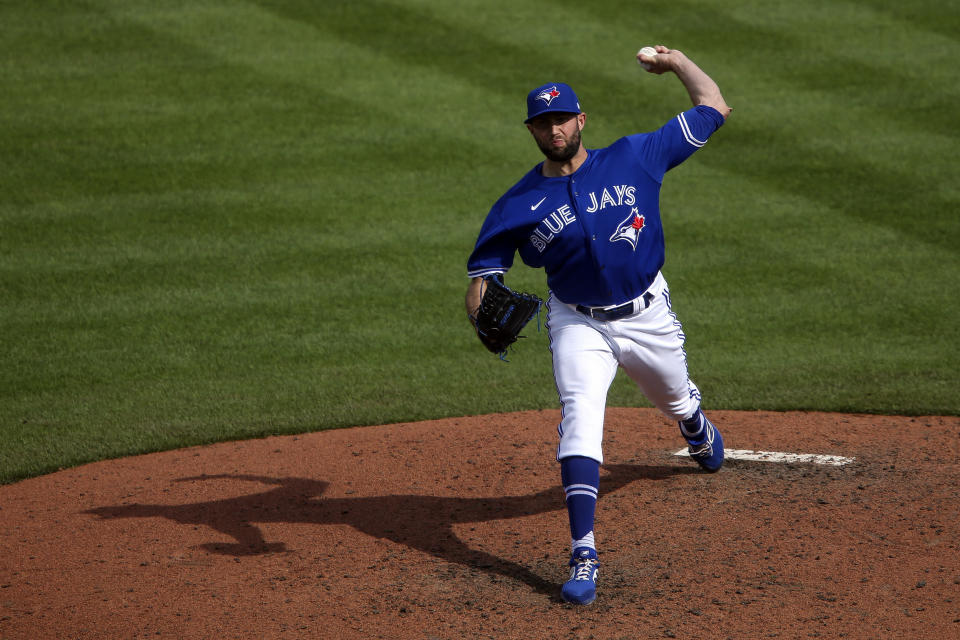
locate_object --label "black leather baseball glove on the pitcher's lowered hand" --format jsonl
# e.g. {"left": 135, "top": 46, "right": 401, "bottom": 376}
{"left": 470, "top": 275, "right": 543, "bottom": 360}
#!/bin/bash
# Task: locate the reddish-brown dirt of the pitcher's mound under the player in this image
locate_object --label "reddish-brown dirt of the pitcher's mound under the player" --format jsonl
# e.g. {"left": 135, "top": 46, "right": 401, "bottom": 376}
{"left": 0, "top": 409, "right": 960, "bottom": 640}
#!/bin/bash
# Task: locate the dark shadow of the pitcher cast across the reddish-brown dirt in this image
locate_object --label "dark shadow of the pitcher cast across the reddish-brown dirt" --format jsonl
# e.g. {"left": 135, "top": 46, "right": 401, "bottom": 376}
{"left": 86, "top": 465, "right": 698, "bottom": 595}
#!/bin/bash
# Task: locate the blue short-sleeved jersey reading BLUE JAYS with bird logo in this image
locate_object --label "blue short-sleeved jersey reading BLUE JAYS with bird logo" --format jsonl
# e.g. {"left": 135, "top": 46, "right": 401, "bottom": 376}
{"left": 467, "top": 106, "right": 723, "bottom": 306}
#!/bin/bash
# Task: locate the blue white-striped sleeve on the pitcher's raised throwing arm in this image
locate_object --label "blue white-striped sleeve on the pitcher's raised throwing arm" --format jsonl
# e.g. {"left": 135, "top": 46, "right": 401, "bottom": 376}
{"left": 628, "top": 105, "right": 723, "bottom": 182}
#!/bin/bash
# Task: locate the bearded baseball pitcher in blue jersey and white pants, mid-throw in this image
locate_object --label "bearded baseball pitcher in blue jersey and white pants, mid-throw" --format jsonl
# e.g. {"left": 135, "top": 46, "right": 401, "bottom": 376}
{"left": 466, "top": 45, "right": 730, "bottom": 604}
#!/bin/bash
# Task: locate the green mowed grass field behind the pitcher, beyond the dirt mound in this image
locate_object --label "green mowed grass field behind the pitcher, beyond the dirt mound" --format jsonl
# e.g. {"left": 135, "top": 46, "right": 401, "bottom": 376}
{"left": 0, "top": 0, "right": 960, "bottom": 482}
